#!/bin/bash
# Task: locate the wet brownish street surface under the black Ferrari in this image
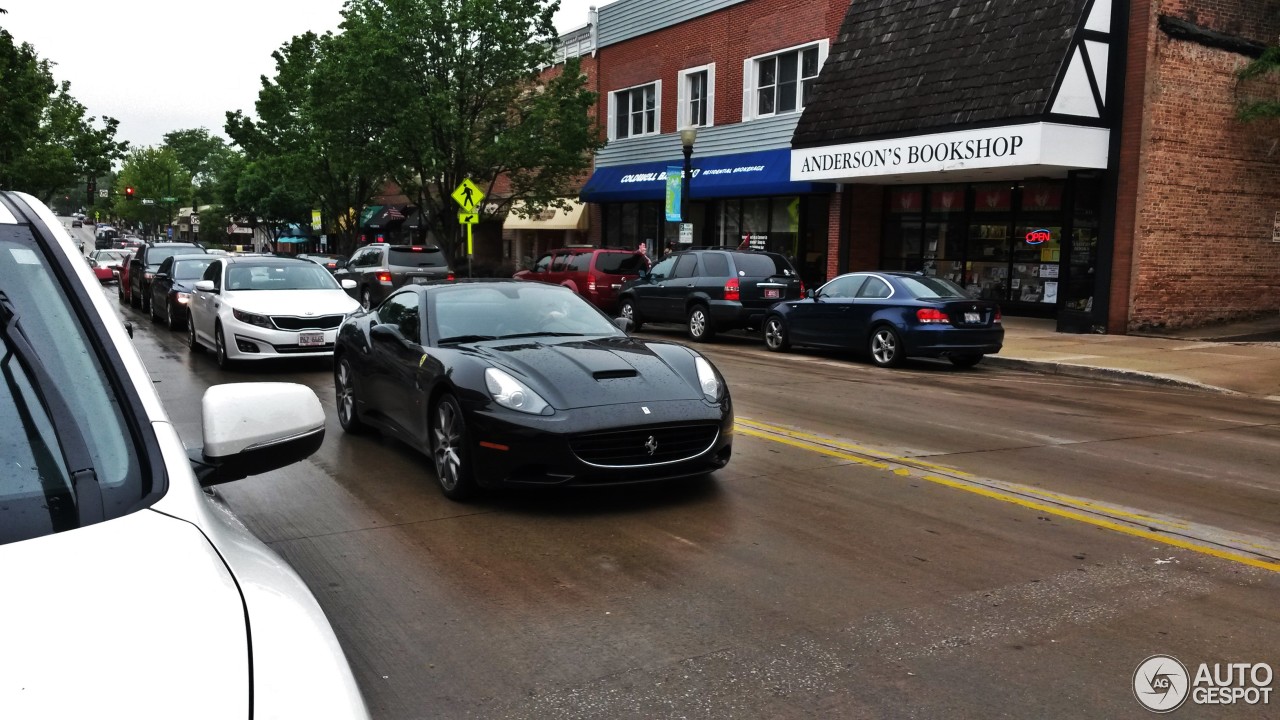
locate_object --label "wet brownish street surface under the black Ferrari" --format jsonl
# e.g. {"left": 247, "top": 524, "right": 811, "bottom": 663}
{"left": 85, "top": 226, "right": 1280, "bottom": 719}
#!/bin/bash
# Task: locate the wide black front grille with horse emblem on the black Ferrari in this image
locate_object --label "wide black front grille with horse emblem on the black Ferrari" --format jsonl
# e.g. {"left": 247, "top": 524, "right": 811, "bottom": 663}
{"left": 570, "top": 423, "right": 719, "bottom": 468}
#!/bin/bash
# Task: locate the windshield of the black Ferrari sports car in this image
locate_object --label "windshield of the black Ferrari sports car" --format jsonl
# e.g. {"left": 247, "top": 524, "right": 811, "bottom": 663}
{"left": 428, "top": 283, "right": 622, "bottom": 343}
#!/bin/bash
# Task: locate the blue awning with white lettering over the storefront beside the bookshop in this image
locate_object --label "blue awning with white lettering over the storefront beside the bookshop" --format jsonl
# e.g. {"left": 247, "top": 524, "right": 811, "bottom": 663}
{"left": 579, "top": 149, "right": 836, "bottom": 202}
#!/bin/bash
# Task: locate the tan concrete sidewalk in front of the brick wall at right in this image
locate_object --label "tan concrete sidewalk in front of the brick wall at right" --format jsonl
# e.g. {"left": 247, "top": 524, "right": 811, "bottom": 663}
{"left": 983, "top": 316, "right": 1280, "bottom": 401}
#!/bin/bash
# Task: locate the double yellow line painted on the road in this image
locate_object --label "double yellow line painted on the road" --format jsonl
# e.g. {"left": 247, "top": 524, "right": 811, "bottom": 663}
{"left": 733, "top": 418, "right": 1280, "bottom": 573}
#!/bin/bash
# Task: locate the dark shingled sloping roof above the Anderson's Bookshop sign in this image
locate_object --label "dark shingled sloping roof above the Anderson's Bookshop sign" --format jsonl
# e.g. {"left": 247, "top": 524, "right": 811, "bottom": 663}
{"left": 792, "top": 0, "right": 1089, "bottom": 147}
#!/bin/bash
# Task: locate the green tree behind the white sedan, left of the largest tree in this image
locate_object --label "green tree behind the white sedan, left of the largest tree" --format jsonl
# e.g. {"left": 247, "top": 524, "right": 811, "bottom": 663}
{"left": 227, "top": 32, "right": 381, "bottom": 252}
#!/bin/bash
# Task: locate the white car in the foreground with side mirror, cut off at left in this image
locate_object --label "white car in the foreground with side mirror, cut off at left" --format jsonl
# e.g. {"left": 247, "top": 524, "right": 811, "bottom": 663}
{"left": 0, "top": 192, "right": 369, "bottom": 720}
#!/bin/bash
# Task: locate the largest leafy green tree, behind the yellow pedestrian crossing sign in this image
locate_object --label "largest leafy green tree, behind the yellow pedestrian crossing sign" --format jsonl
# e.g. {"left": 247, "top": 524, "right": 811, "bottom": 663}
{"left": 329, "top": 0, "right": 600, "bottom": 263}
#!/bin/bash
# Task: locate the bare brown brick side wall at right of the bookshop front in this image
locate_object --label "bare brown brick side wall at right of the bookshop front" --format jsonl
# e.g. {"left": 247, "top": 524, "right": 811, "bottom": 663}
{"left": 1131, "top": 0, "right": 1280, "bottom": 332}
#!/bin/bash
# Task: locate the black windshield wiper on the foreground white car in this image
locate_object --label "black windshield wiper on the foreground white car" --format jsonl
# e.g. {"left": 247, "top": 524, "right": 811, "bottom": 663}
{"left": 0, "top": 291, "right": 105, "bottom": 528}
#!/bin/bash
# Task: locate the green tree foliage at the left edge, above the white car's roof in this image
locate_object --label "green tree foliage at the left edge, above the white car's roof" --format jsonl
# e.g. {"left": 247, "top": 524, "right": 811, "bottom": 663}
{"left": 0, "top": 29, "right": 128, "bottom": 202}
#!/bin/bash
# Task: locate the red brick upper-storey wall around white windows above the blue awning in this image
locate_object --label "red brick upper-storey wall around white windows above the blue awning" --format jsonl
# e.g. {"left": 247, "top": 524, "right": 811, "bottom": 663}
{"left": 598, "top": 0, "right": 849, "bottom": 132}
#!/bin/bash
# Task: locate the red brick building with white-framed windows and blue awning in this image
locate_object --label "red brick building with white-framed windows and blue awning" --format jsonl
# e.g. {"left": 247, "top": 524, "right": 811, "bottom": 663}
{"left": 581, "top": 0, "right": 849, "bottom": 281}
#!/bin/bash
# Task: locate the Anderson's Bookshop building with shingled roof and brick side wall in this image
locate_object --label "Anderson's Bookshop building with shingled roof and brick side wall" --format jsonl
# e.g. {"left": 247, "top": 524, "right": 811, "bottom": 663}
{"left": 791, "top": 0, "right": 1280, "bottom": 333}
